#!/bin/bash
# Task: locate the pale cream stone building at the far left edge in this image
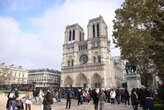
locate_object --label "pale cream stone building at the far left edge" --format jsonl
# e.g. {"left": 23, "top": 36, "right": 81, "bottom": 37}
{"left": 0, "top": 63, "right": 28, "bottom": 85}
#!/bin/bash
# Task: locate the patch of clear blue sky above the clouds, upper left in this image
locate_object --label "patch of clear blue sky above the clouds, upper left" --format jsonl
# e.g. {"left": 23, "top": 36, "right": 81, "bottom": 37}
{"left": 0, "top": 0, "right": 64, "bottom": 32}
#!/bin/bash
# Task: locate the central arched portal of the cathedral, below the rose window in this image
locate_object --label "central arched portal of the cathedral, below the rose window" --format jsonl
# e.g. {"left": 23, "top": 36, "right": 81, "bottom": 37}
{"left": 76, "top": 73, "right": 88, "bottom": 88}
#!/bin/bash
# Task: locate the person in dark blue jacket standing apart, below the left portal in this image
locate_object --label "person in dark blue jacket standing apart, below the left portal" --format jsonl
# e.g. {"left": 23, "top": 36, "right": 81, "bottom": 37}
{"left": 66, "top": 89, "right": 72, "bottom": 109}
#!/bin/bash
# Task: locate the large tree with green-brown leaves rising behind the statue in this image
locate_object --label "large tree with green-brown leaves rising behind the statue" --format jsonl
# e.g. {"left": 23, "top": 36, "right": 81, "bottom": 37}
{"left": 113, "top": 0, "right": 163, "bottom": 86}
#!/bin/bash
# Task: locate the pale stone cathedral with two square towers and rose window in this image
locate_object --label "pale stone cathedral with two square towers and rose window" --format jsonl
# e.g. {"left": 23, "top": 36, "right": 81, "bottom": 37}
{"left": 61, "top": 16, "right": 125, "bottom": 88}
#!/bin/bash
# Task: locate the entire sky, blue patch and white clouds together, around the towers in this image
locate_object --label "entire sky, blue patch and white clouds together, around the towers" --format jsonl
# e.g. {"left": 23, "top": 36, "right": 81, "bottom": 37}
{"left": 0, "top": 0, "right": 123, "bottom": 69}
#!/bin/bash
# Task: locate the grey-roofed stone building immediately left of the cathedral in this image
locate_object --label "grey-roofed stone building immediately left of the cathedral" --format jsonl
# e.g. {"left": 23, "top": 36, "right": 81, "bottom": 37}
{"left": 28, "top": 69, "right": 61, "bottom": 87}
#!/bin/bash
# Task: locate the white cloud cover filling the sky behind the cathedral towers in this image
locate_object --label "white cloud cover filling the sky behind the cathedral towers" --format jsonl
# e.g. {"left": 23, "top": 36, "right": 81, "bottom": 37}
{"left": 0, "top": 0, "right": 123, "bottom": 69}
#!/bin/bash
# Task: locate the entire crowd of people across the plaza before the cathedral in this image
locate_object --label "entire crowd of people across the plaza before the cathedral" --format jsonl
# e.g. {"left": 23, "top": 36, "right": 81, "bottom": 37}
{"left": 6, "top": 86, "right": 154, "bottom": 110}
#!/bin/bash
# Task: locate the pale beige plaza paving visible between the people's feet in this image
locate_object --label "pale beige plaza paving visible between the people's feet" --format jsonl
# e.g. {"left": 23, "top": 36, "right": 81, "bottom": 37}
{"left": 0, "top": 94, "right": 140, "bottom": 110}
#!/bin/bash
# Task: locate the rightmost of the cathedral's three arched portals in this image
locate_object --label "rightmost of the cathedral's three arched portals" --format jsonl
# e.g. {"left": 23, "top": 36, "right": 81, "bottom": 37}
{"left": 91, "top": 74, "right": 102, "bottom": 88}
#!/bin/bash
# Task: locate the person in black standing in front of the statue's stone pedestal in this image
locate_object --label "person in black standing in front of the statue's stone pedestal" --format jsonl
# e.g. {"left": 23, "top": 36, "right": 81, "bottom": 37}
{"left": 131, "top": 88, "right": 138, "bottom": 110}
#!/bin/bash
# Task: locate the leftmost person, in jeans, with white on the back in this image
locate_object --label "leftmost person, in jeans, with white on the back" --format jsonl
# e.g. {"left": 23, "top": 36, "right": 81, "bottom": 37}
{"left": 7, "top": 88, "right": 18, "bottom": 110}
